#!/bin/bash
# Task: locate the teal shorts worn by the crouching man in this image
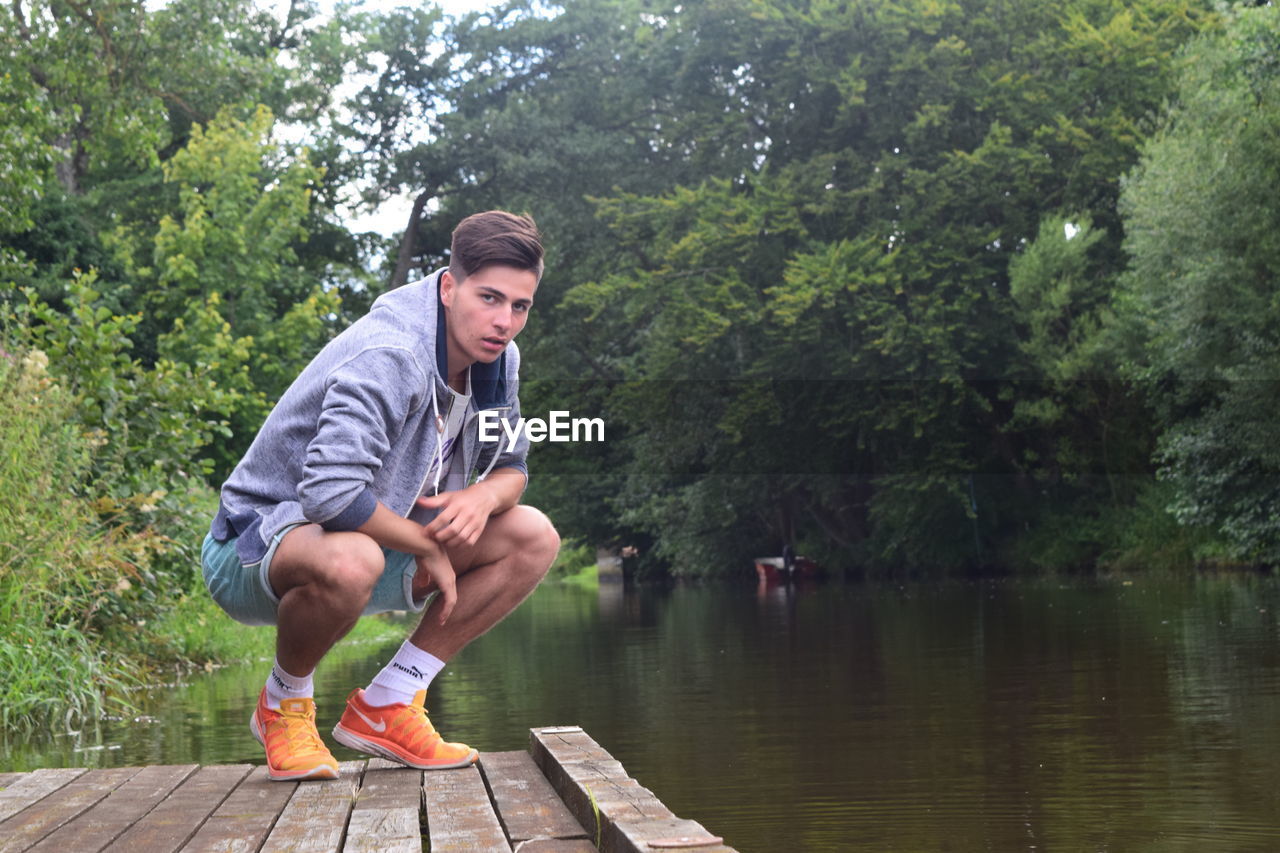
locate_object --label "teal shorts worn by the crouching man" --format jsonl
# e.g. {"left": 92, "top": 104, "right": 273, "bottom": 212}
{"left": 200, "top": 524, "right": 430, "bottom": 625}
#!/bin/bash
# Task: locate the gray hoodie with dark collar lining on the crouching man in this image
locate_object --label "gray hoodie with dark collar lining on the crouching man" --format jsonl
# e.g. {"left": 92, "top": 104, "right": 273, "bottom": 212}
{"left": 210, "top": 270, "right": 529, "bottom": 564}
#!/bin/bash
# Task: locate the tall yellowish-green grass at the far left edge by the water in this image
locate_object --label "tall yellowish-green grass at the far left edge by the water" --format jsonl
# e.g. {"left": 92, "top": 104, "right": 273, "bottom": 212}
{"left": 0, "top": 350, "right": 144, "bottom": 727}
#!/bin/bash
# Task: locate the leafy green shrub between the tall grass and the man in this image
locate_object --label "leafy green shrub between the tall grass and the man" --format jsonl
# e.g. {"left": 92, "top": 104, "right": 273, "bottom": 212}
{"left": 0, "top": 274, "right": 240, "bottom": 666}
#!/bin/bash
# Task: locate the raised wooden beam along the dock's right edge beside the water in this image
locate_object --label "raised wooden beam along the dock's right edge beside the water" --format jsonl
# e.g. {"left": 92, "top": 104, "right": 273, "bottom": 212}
{"left": 530, "top": 726, "right": 732, "bottom": 853}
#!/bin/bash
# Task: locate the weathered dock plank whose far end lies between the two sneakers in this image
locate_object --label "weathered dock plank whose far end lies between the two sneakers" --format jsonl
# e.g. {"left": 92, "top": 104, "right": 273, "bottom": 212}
{"left": 262, "top": 761, "right": 365, "bottom": 853}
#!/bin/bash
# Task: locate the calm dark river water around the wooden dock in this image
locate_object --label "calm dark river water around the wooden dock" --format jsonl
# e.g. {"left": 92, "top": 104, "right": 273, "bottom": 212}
{"left": 0, "top": 576, "right": 1280, "bottom": 853}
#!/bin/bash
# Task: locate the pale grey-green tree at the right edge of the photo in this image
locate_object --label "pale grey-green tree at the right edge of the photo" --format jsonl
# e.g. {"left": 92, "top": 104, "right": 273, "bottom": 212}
{"left": 1117, "top": 6, "right": 1280, "bottom": 564}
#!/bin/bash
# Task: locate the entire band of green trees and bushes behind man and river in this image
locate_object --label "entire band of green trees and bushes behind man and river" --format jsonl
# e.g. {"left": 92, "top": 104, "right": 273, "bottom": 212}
{"left": 0, "top": 0, "right": 1280, "bottom": 725}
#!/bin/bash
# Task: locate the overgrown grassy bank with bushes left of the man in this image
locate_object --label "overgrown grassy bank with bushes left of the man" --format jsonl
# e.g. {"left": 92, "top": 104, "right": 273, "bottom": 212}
{"left": 0, "top": 350, "right": 403, "bottom": 730}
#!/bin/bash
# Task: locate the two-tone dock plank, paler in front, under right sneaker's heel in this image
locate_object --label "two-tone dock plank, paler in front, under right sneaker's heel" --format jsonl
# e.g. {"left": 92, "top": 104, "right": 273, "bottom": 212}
{"left": 342, "top": 758, "right": 422, "bottom": 853}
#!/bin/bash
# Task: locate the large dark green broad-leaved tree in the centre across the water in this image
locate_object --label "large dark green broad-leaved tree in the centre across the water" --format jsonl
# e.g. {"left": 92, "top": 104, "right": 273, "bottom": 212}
{"left": 514, "top": 3, "right": 1199, "bottom": 566}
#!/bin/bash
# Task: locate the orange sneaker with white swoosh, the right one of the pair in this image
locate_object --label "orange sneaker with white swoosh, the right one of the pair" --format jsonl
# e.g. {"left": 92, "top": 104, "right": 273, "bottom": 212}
{"left": 333, "top": 688, "right": 480, "bottom": 770}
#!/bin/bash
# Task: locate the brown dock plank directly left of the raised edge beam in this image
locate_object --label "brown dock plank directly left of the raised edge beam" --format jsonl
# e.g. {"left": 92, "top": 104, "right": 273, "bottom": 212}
{"left": 480, "top": 752, "right": 594, "bottom": 849}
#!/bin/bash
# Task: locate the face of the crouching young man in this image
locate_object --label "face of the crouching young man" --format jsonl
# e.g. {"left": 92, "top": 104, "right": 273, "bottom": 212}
{"left": 440, "top": 266, "right": 538, "bottom": 371}
